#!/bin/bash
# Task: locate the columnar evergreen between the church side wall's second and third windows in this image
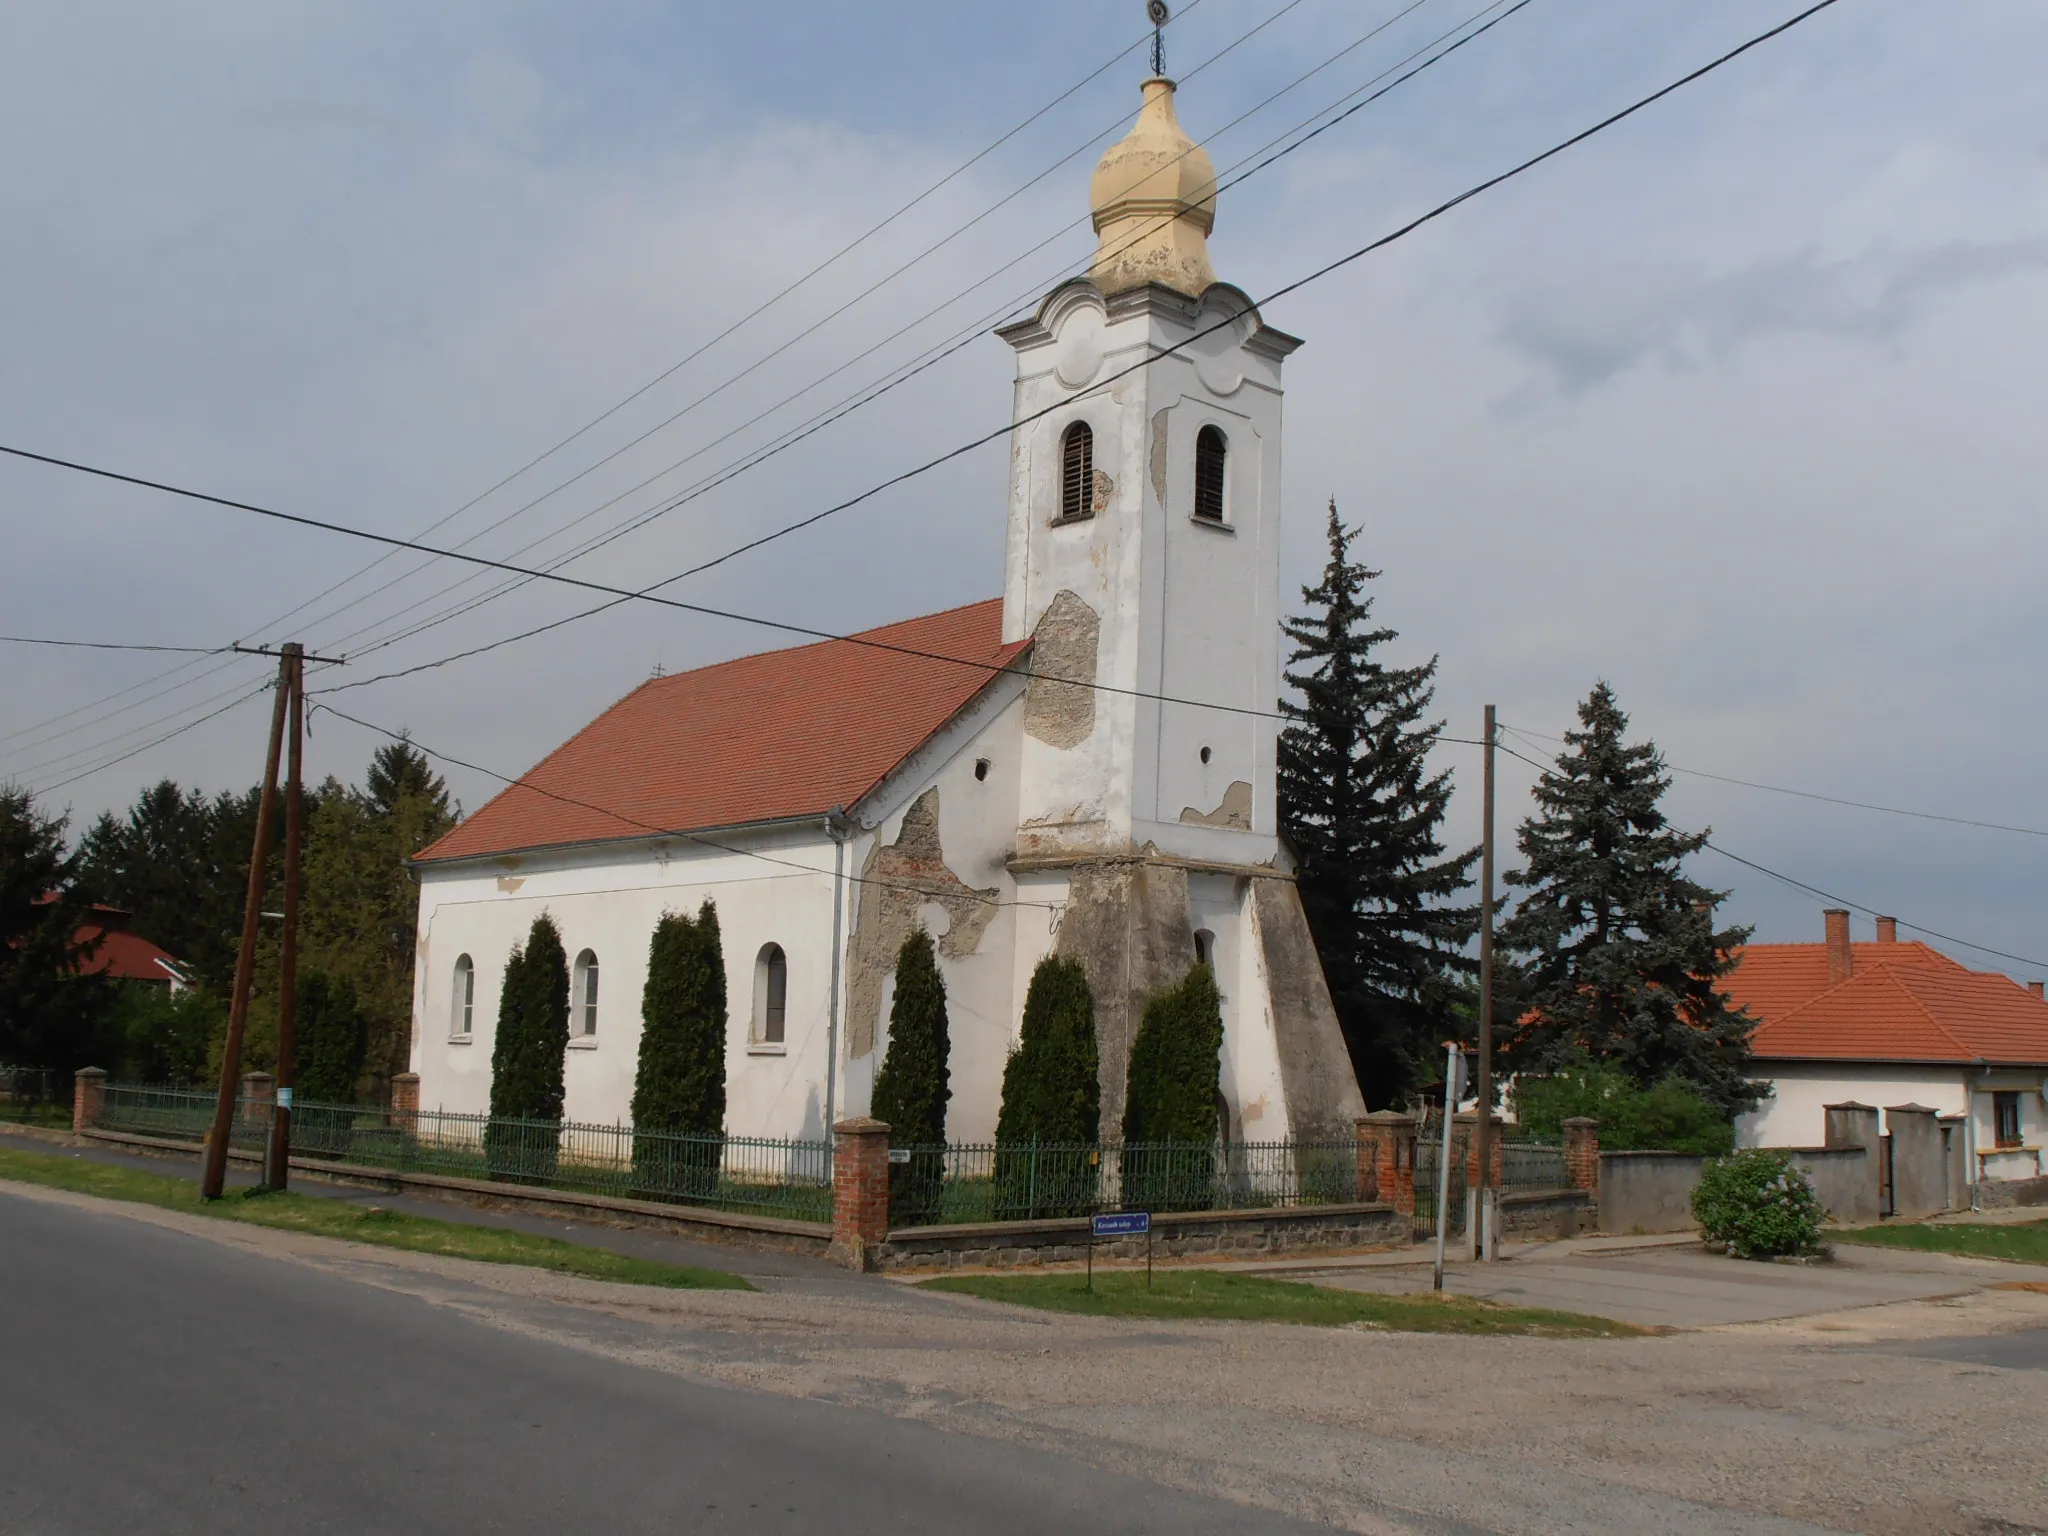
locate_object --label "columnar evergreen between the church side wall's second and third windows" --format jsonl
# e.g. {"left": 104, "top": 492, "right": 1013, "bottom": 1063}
{"left": 633, "top": 899, "right": 727, "bottom": 1196}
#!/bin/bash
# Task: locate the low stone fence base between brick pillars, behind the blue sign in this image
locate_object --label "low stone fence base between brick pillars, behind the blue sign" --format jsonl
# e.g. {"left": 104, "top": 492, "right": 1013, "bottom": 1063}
{"left": 868, "top": 1202, "right": 1409, "bottom": 1270}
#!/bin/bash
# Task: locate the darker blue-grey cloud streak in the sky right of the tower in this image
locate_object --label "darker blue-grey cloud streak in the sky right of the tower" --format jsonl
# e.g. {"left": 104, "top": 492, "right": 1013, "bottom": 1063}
{"left": 1497, "top": 240, "right": 2048, "bottom": 395}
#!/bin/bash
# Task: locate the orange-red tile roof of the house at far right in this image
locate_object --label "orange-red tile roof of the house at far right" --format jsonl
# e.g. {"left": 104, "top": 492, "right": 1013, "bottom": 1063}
{"left": 1726, "top": 944, "right": 2048, "bottom": 1065}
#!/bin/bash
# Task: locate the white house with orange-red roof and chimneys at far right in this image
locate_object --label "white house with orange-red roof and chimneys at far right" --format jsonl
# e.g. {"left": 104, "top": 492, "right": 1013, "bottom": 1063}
{"left": 1726, "top": 909, "right": 2048, "bottom": 1184}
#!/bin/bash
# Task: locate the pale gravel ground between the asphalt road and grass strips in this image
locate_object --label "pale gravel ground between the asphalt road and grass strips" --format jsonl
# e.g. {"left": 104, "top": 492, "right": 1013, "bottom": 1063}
{"left": 8, "top": 1186, "right": 2048, "bottom": 1536}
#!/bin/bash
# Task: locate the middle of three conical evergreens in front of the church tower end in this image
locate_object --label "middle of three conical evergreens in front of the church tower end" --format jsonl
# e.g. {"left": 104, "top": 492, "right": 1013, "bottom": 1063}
{"left": 995, "top": 954, "right": 1102, "bottom": 1217}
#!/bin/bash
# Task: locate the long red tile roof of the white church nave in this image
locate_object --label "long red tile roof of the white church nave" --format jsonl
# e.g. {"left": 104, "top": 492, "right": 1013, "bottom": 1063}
{"left": 418, "top": 598, "right": 1030, "bottom": 864}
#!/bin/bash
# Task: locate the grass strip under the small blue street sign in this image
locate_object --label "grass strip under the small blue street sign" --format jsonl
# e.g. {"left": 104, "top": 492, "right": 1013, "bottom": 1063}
{"left": 922, "top": 1270, "right": 1647, "bottom": 1339}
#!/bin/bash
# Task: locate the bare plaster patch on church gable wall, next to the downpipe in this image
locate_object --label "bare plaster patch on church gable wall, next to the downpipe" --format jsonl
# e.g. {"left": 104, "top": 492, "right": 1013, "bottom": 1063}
{"left": 846, "top": 786, "right": 1001, "bottom": 1059}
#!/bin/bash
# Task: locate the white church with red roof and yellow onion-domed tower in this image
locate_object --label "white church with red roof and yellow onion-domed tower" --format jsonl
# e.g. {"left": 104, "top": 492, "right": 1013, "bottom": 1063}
{"left": 412, "top": 78, "right": 1364, "bottom": 1143}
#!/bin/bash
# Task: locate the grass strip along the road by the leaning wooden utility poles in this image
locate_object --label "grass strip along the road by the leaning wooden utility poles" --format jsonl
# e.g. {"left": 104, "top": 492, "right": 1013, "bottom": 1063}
{"left": 0, "top": 1147, "right": 752, "bottom": 1290}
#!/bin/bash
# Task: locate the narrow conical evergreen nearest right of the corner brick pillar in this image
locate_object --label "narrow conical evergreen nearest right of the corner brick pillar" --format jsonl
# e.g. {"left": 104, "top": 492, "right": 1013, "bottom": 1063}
{"left": 870, "top": 928, "right": 952, "bottom": 1227}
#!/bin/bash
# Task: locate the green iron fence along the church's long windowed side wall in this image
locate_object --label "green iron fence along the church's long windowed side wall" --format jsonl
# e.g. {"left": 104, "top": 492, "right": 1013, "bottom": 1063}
{"left": 100, "top": 1085, "right": 831, "bottom": 1221}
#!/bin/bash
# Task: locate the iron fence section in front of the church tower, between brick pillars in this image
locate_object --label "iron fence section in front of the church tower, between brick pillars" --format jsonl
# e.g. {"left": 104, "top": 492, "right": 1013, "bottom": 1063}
{"left": 889, "top": 1141, "right": 1364, "bottom": 1227}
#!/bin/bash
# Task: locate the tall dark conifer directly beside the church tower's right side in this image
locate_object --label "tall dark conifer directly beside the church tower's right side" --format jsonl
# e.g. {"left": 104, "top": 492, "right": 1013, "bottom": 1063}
{"left": 1278, "top": 500, "right": 1479, "bottom": 1108}
